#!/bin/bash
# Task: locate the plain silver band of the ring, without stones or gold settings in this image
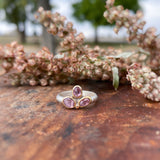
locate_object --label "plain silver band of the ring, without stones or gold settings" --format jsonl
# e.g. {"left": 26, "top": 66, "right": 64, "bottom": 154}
{"left": 56, "top": 90, "right": 98, "bottom": 103}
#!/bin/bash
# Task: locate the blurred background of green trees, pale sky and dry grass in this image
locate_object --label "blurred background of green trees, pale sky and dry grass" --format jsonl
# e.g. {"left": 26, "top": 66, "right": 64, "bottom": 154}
{"left": 0, "top": 0, "right": 160, "bottom": 53}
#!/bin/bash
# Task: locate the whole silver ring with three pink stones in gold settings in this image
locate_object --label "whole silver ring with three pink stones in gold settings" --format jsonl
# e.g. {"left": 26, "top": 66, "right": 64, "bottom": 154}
{"left": 56, "top": 85, "right": 98, "bottom": 109}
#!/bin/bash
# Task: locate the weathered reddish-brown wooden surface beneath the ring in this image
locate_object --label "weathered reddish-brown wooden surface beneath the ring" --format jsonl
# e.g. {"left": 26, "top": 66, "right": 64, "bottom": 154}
{"left": 0, "top": 81, "right": 160, "bottom": 160}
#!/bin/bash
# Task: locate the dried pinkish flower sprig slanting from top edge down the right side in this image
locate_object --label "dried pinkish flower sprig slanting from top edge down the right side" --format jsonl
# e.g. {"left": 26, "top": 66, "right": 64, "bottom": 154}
{"left": 104, "top": 0, "right": 160, "bottom": 70}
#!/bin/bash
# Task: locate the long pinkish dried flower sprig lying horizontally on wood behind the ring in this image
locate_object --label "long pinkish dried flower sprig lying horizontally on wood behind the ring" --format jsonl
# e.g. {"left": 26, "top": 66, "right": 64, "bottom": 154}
{"left": 0, "top": 42, "right": 128, "bottom": 86}
